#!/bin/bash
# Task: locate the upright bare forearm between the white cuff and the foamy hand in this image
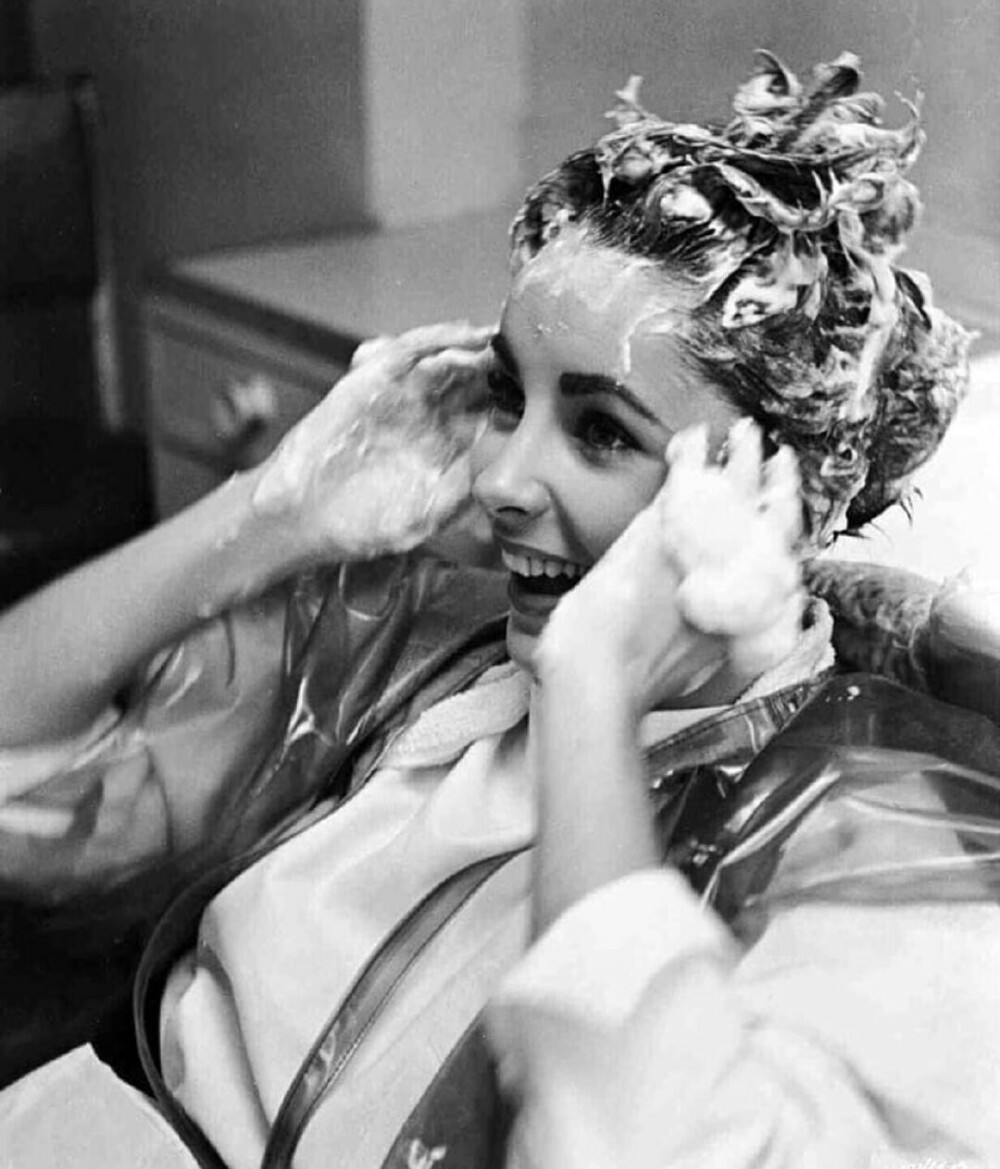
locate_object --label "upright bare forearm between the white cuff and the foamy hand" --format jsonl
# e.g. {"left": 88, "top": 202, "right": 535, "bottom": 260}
{"left": 531, "top": 655, "right": 660, "bottom": 933}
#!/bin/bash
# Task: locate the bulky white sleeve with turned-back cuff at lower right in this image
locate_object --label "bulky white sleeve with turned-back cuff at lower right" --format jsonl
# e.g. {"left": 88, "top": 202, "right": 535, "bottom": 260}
{"left": 489, "top": 870, "right": 1000, "bottom": 1169}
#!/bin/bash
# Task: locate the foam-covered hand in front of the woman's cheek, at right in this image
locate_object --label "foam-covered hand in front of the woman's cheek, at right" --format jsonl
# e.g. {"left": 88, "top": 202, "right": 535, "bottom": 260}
{"left": 540, "top": 420, "right": 805, "bottom": 713}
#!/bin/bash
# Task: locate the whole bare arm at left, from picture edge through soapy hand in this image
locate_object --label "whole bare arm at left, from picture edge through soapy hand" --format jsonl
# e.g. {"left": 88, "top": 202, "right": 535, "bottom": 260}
{"left": 0, "top": 325, "right": 490, "bottom": 747}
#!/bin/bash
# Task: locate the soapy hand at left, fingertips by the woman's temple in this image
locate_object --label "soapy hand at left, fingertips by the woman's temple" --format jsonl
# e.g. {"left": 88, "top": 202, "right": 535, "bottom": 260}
{"left": 253, "top": 324, "right": 495, "bottom": 560}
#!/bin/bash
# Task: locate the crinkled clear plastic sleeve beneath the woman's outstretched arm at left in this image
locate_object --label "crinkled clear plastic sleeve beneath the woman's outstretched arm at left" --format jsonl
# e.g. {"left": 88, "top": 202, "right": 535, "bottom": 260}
{"left": 0, "top": 558, "right": 505, "bottom": 929}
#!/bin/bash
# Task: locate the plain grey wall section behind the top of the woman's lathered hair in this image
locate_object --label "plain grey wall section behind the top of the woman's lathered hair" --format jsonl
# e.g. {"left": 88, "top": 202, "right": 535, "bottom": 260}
{"left": 525, "top": 0, "right": 1000, "bottom": 237}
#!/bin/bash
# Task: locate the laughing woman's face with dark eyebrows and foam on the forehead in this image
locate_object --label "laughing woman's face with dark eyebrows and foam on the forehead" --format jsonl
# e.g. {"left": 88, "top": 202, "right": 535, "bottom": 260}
{"left": 473, "top": 229, "right": 738, "bottom": 664}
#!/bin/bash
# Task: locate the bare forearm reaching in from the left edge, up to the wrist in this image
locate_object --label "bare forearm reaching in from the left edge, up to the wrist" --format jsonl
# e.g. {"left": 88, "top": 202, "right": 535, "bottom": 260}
{"left": 0, "top": 462, "right": 313, "bottom": 747}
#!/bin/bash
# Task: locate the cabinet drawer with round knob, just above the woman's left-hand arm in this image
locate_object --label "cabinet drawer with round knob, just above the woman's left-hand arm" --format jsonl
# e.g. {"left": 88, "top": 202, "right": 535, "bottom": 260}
{"left": 150, "top": 331, "right": 343, "bottom": 475}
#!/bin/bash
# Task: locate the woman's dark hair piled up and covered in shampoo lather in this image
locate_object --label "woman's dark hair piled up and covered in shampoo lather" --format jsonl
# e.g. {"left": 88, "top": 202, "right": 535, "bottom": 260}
{"left": 511, "top": 53, "right": 971, "bottom": 546}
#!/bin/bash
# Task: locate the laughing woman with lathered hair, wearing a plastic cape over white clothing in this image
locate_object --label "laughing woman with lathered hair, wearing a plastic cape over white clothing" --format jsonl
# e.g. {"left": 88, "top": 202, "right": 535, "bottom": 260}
{"left": 0, "top": 45, "right": 1000, "bottom": 1169}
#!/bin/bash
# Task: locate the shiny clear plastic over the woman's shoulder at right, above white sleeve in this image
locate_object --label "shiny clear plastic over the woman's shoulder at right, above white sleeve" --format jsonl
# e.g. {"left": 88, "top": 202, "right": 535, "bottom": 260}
{"left": 701, "top": 675, "right": 1000, "bottom": 940}
